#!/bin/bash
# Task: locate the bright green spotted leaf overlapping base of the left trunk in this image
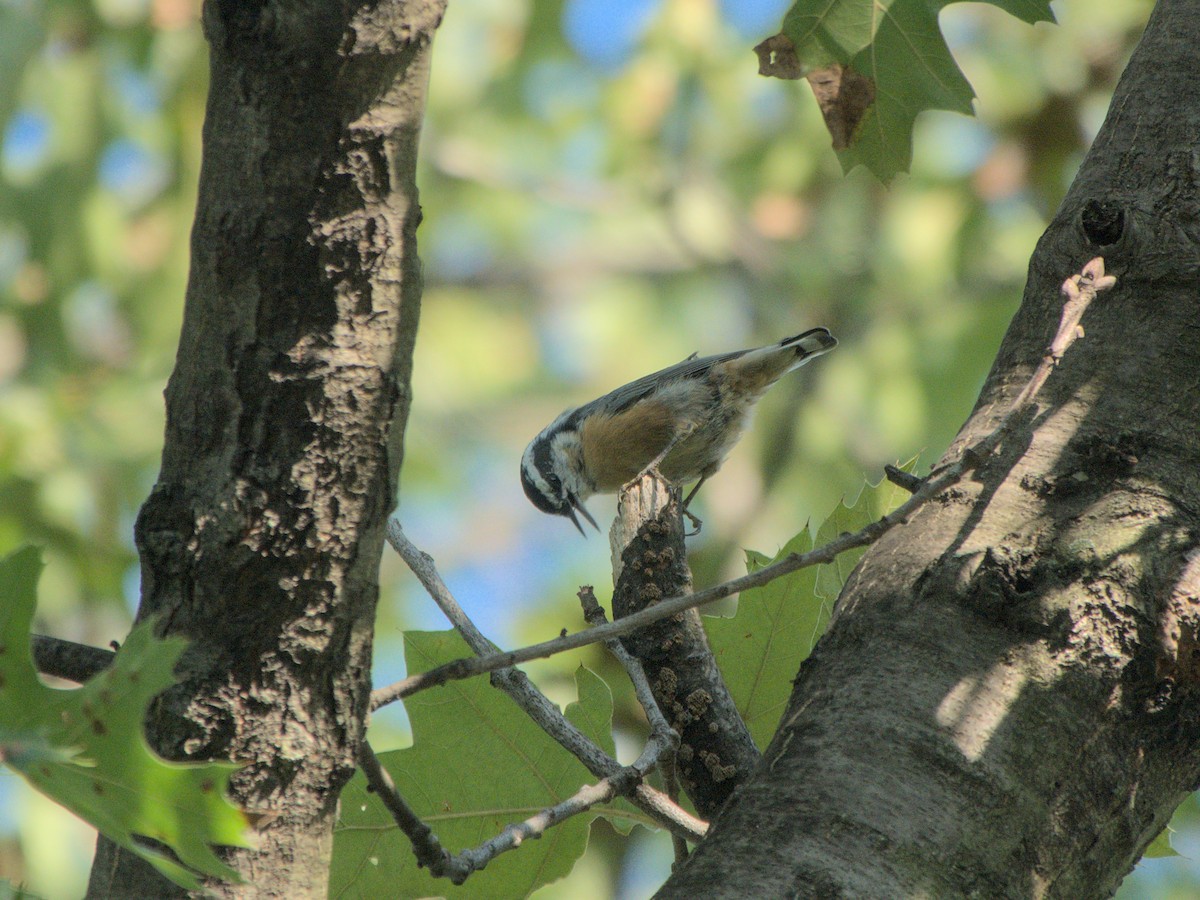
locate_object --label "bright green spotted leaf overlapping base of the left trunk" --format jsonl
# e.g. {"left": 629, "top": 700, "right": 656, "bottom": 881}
{"left": 0, "top": 548, "right": 247, "bottom": 889}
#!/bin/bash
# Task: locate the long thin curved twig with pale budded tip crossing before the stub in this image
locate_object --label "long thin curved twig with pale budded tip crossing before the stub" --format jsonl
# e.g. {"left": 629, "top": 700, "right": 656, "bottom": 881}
{"left": 371, "top": 257, "right": 1116, "bottom": 709}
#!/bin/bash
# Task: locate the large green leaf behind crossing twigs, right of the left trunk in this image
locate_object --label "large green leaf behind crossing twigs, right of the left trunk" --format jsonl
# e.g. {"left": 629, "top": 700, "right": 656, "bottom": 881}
{"left": 330, "top": 631, "right": 647, "bottom": 898}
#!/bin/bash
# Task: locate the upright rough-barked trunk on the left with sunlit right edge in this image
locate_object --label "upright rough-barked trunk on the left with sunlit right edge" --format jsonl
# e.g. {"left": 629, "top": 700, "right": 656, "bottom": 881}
{"left": 89, "top": 0, "right": 444, "bottom": 898}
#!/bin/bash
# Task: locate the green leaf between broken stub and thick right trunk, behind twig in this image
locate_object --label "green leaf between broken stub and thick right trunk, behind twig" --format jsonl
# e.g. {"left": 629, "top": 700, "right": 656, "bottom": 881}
{"left": 704, "top": 460, "right": 916, "bottom": 748}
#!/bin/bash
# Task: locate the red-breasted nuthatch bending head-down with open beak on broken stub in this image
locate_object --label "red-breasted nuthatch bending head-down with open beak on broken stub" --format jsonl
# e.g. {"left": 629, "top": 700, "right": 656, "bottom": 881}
{"left": 521, "top": 328, "right": 838, "bottom": 534}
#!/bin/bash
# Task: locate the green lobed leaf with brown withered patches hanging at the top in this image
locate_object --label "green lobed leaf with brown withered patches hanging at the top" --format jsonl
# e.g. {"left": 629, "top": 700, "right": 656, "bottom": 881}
{"left": 768, "top": 0, "right": 1054, "bottom": 181}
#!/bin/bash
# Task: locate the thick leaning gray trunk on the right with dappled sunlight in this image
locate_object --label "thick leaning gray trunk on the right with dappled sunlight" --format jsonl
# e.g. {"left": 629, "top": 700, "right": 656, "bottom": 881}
{"left": 660, "top": 0, "right": 1200, "bottom": 898}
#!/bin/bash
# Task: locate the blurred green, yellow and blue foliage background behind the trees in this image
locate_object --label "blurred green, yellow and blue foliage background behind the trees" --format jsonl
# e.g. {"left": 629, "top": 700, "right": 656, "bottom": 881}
{"left": 0, "top": 0, "right": 1200, "bottom": 899}
